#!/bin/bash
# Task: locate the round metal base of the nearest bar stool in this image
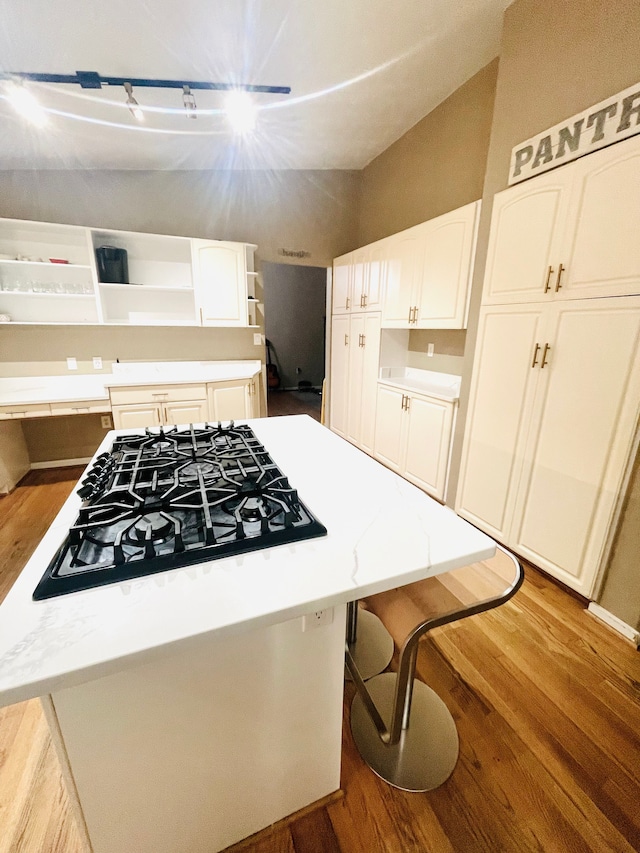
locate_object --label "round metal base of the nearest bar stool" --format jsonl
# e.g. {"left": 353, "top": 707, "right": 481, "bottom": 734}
{"left": 351, "top": 672, "right": 458, "bottom": 791}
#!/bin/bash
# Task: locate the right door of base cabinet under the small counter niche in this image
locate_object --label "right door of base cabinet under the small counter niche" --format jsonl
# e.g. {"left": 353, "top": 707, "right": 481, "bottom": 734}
{"left": 403, "top": 395, "right": 453, "bottom": 500}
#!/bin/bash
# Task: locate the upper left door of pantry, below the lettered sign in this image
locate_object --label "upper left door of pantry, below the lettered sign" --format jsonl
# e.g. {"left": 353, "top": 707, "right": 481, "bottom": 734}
{"left": 482, "top": 171, "right": 573, "bottom": 305}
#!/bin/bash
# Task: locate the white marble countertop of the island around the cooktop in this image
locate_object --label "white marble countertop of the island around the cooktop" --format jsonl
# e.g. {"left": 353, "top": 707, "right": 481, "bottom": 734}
{"left": 0, "top": 415, "right": 494, "bottom": 705}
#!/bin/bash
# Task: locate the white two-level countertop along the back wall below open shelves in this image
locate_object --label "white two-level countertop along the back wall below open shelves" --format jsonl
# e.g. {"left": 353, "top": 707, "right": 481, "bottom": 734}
{"left": 0, "top": 360, "right": 261, "bottom": 406}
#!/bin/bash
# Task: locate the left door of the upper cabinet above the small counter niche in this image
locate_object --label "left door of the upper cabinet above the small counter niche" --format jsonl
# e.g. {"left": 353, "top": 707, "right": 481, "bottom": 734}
{"left": 382, "top": 228, "right": 423, "bottom": 328}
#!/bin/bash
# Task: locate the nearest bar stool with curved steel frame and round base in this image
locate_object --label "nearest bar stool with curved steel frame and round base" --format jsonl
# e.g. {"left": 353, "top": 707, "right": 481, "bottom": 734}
{"left": 346, "top": 546, "right": 524, "bottom": 791}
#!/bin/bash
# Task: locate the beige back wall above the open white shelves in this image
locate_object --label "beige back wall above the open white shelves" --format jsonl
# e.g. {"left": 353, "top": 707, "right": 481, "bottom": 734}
{"left": 0, "top": 170, "right": 359, "bottom": 266}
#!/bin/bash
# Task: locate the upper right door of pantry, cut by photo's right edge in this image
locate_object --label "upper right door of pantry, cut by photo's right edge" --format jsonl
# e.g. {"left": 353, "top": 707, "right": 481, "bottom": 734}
{"left": 557, "top": 136, "right": 640, "bottom": 299}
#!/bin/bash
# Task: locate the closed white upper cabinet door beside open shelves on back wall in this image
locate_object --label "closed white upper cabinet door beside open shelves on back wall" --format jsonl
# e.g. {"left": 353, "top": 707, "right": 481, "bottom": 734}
{"left": 192, "top": 240, "right": 249, "bottom": 326}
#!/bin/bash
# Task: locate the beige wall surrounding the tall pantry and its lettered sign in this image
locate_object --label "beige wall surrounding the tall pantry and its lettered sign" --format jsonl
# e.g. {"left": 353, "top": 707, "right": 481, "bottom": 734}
{"left": 448, "top": 0, "right": 640, "bottom": 626}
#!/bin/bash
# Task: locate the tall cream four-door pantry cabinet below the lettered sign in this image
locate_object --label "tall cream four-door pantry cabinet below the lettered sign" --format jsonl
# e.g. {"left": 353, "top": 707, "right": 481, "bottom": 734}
{"left": 456, "top": 137, "right": 640, "bottom": 597}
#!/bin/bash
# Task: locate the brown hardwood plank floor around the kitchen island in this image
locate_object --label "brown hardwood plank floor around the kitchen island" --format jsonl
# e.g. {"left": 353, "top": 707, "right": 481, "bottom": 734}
{"left": 0, "top": 469, "right": 640, "bottom": 853}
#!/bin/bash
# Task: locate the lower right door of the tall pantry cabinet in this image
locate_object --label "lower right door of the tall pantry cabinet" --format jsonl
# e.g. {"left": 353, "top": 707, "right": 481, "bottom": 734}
{"left": 511, "top": 297, "right": 640, "bottom": 597}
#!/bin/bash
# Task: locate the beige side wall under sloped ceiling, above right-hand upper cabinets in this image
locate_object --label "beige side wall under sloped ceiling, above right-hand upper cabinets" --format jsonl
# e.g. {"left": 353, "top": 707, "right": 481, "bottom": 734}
{"left": 358, "top": 59, "right": 498, "bottom": 248}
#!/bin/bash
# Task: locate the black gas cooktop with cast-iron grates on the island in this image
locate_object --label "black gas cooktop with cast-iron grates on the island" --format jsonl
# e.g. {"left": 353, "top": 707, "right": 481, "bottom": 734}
{"left": 33, "top": 421, "right": 327, "bottom": 600}
